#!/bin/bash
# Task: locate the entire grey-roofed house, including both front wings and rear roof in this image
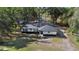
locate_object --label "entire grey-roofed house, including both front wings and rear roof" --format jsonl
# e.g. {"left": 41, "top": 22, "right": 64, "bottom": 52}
{"left": 21, "top": 20, "right": 58, "bottom": 36}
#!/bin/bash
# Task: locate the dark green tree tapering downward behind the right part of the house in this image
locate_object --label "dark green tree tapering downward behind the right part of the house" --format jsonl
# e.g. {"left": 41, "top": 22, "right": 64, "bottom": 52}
{"left": 47, "top": 7, "right": 70, "bottom": 23}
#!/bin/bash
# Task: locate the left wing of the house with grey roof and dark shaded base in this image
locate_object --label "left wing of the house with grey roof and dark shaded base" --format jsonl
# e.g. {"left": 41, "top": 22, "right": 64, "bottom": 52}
{"left": 21, "top": 24, "right": 38, "bottom": 33}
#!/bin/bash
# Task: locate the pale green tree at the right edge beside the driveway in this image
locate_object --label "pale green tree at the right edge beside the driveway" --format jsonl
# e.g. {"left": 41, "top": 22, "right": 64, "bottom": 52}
{"left": 69, "top": 8, "right": 79, "bottom": 33}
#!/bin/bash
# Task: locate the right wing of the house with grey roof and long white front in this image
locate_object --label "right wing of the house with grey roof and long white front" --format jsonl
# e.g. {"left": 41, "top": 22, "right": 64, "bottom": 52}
{"left": 39, "top": 25, "right": 58, "bottom": 36}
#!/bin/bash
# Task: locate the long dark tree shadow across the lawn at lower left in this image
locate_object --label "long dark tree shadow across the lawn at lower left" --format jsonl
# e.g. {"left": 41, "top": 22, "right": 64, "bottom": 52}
{"left": 0, "top": 37, "right": 35, "bottom": 49}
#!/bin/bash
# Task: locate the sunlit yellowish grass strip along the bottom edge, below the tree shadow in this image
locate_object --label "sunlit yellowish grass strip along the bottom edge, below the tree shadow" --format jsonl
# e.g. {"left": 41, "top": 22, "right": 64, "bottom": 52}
{"left": 19, "top": 43, "right": 62, "bottom": 51}
